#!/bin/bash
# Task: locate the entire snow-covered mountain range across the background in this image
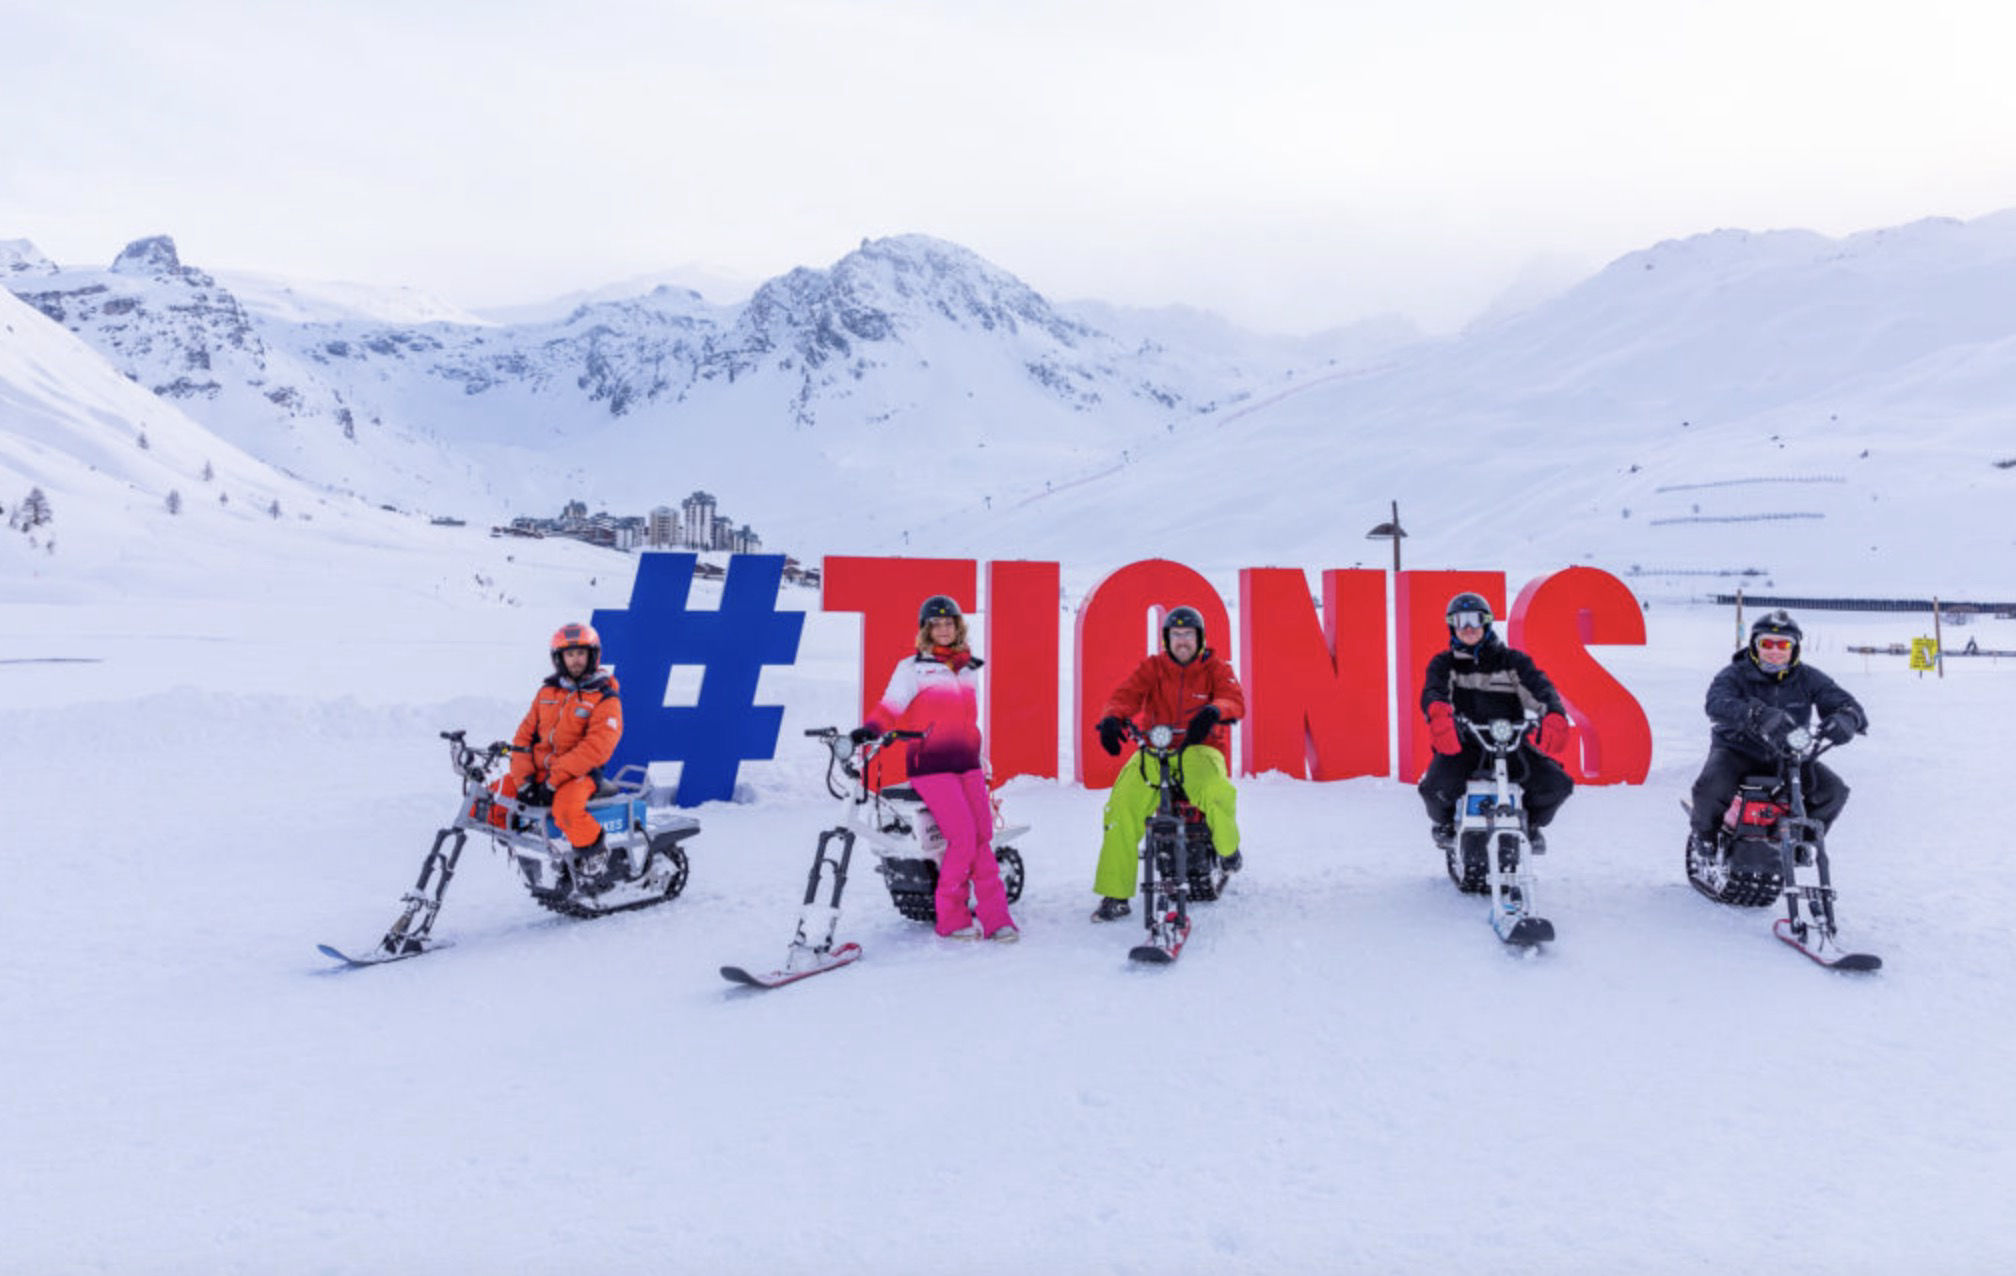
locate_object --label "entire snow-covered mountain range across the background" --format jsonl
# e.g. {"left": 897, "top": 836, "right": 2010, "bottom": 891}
{"left": 0, "top": 212, "right": 2016, "bottom": 595}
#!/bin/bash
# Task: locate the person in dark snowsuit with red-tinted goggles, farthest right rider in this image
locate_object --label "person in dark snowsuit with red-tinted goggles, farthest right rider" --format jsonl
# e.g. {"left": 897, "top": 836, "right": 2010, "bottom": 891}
{"left": 1691, "top": 611, "right": 1869, "bottom": 843}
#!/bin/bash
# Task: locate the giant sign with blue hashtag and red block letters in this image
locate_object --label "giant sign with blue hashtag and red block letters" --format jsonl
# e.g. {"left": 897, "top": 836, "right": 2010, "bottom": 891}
{"left": 593, "top": 554, "right": 1651, "bottom": 806}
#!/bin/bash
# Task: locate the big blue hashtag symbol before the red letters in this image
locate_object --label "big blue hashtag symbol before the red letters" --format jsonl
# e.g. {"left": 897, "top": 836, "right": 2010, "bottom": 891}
{"left": 591, "top": 554, "right": 804, "bottom": 806}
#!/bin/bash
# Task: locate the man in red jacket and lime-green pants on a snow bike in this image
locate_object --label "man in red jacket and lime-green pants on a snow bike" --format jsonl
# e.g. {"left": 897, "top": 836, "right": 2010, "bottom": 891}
{"left": 1093, "top": 607, "right": 1246, "bottom": 921}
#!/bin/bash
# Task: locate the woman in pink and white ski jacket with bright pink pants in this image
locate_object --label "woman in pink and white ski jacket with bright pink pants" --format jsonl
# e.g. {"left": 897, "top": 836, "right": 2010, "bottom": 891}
{"left": 855, "top": 595, "right": 1020, "bottom": 941}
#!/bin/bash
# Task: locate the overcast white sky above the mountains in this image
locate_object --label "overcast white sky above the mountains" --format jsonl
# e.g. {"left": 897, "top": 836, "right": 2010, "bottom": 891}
{"left": 0, "top": 0, "right": 2016, "bottom": 331}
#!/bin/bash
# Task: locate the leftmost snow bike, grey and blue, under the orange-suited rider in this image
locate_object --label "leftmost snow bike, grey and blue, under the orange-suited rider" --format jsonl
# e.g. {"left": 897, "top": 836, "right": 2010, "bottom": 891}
{"left": 319, "top": 732, "right": 700, "bottom": 966}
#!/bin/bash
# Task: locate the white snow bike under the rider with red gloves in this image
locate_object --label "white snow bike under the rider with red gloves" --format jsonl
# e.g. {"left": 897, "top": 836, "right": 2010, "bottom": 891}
{"left": 1443, "top": 712, "right": 1554, "bottom": 947}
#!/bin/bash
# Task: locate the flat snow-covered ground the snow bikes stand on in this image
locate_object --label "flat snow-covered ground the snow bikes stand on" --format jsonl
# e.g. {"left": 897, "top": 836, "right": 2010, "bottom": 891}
{"left": 0, "top": 552, "right": 2016, "bottom": 1276}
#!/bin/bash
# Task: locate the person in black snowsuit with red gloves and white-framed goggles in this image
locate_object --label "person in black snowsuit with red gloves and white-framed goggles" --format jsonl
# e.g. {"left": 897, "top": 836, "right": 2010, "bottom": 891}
{"left": 1419, "top": 593, "right": 1574, "bottom": 851}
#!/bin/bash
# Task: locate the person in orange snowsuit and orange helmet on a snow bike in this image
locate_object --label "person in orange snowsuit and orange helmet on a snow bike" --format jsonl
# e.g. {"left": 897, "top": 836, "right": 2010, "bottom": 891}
{"left": 498, "top": 625, "right": 623, "bottom": 851}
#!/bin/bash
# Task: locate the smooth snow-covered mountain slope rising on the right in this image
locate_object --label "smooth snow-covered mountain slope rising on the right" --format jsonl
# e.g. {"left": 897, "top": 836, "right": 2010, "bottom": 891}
{"left": 935, "top": 212, "right": 2016, "bottom": 597}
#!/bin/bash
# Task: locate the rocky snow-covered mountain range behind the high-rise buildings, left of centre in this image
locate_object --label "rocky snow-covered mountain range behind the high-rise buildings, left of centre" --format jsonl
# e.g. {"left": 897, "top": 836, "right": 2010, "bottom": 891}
{"left": 14, "top": 236, "right": 1322, "bottom": 542}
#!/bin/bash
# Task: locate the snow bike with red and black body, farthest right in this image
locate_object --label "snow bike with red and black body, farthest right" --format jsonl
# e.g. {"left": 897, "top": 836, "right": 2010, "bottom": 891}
{"left": 1681, "top": 726, "right": 1883, "bottom": 970}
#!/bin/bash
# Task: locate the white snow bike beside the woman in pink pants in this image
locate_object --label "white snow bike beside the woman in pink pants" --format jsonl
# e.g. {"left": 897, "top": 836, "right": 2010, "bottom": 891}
{"left": 722, "top": 726, "right": 1028, "bottom": 988}
